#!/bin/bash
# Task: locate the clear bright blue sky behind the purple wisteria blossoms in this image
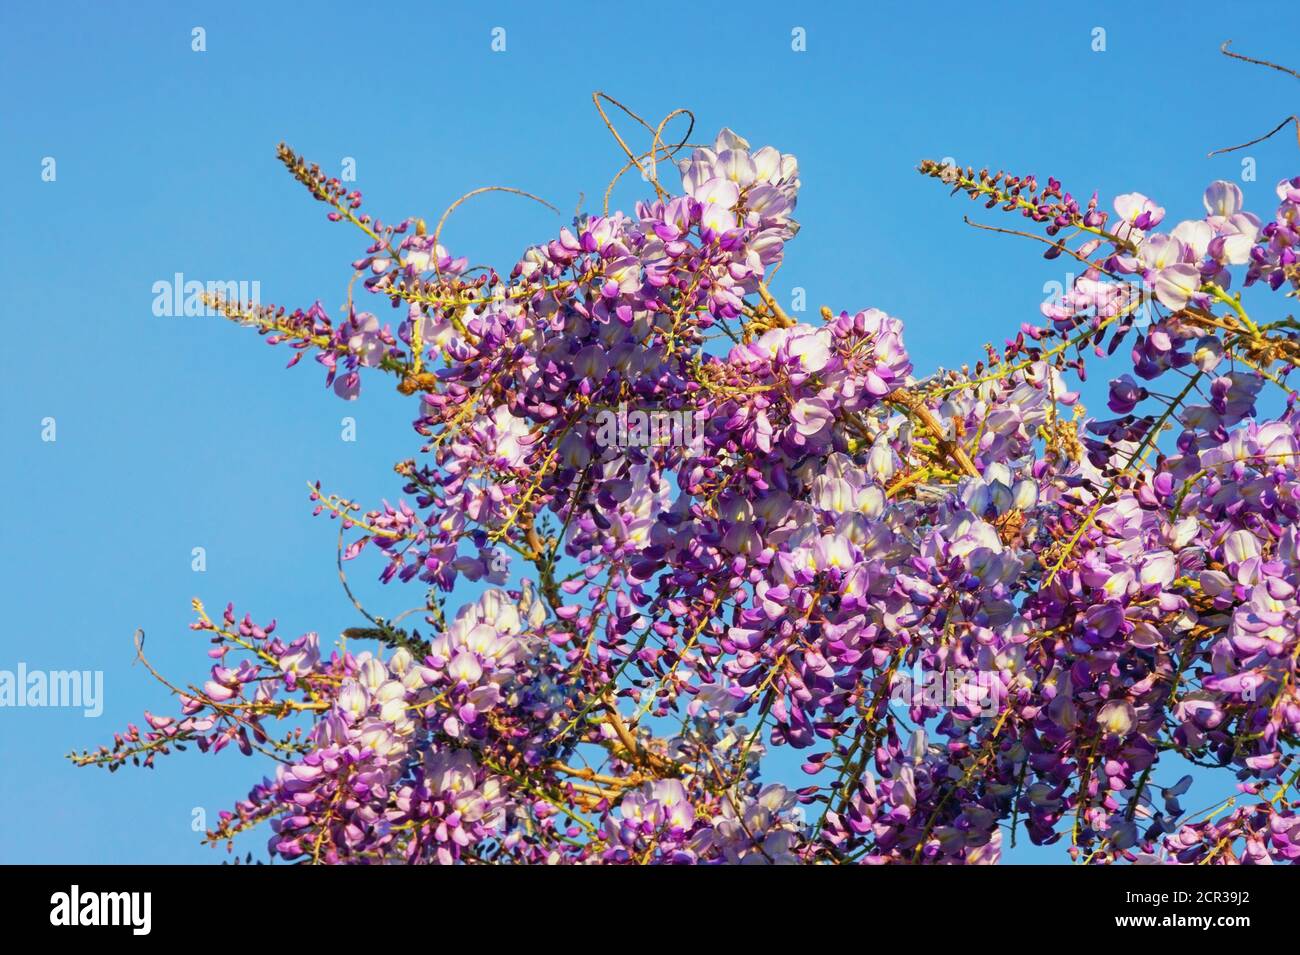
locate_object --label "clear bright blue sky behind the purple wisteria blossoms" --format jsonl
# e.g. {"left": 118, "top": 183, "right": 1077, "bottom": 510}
{"left": 0, "top": 1, "right": 1300, "bottom": 863}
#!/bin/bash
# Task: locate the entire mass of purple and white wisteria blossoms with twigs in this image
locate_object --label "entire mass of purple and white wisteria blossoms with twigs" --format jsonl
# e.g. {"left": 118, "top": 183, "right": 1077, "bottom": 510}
{"left": 74, "top": 121, "right": 1300, "bottom": 864}
